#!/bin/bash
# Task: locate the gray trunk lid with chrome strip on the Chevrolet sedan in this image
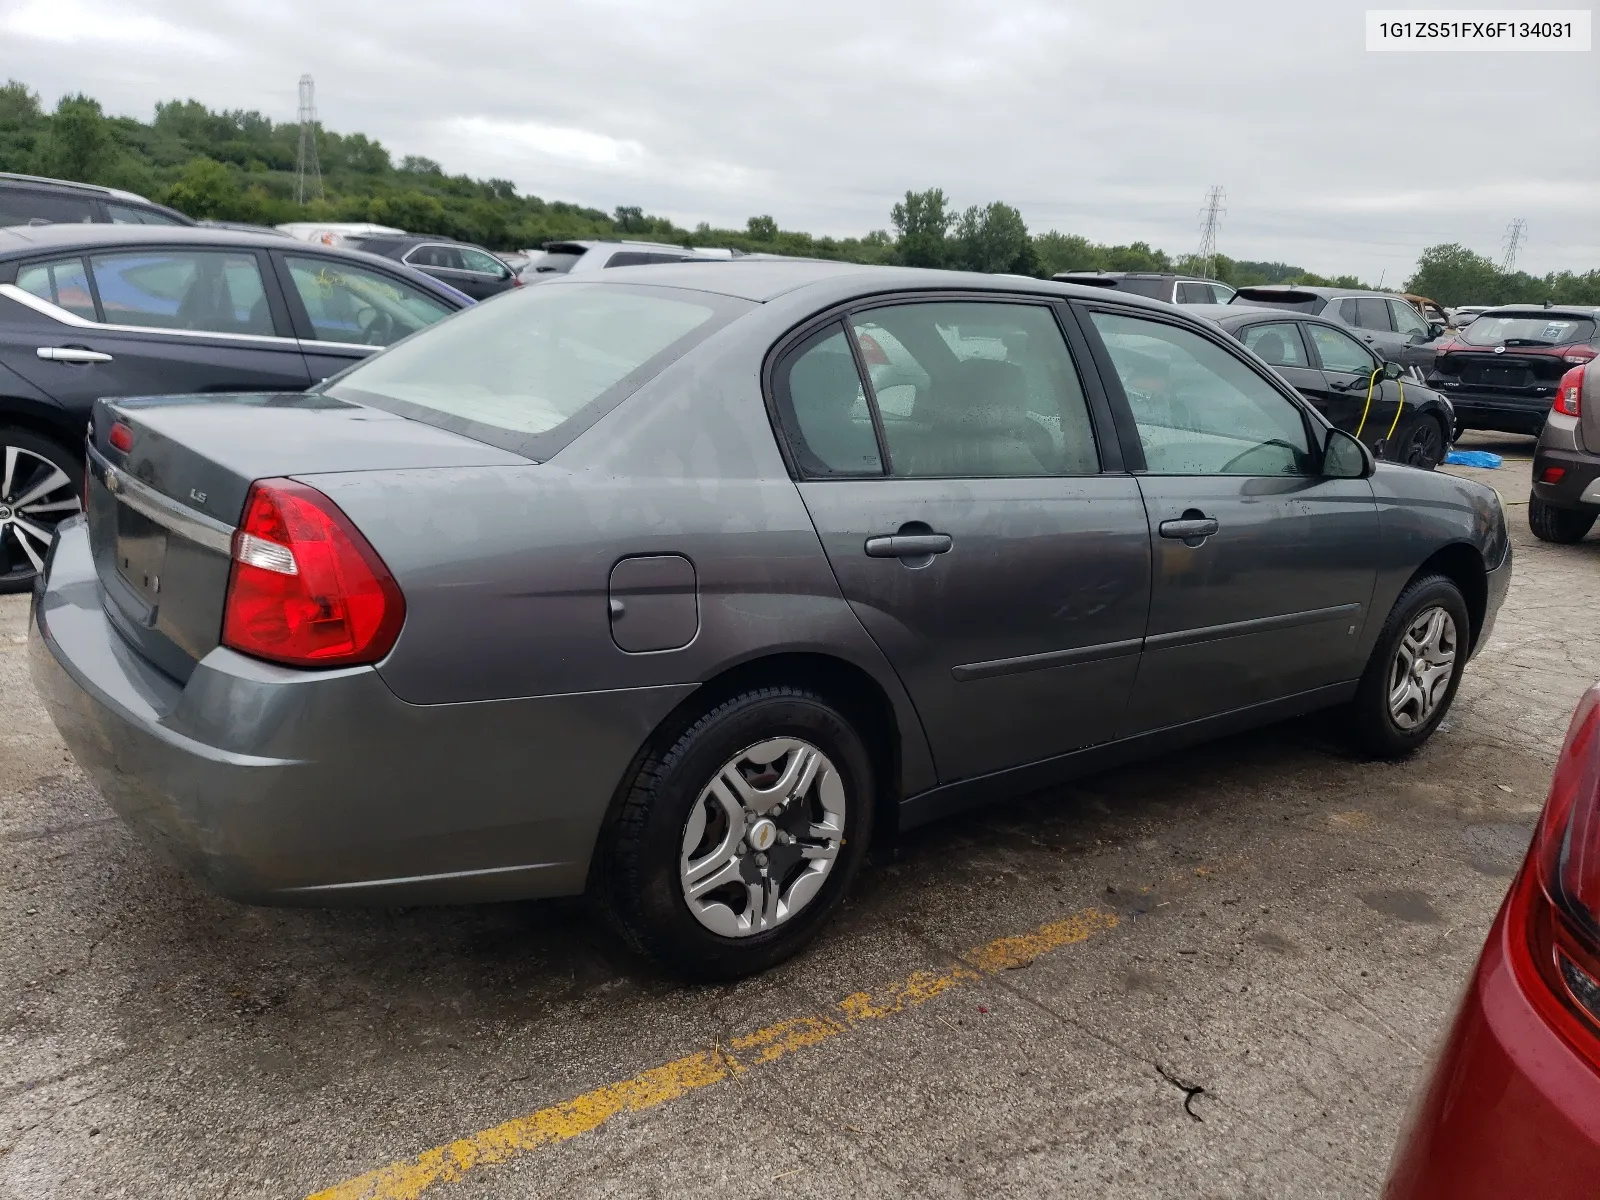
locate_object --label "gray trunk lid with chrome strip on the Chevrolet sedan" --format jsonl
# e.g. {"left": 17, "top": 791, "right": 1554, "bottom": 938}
{"left": 88, "top": 392, "right": 526, "bottom": 680}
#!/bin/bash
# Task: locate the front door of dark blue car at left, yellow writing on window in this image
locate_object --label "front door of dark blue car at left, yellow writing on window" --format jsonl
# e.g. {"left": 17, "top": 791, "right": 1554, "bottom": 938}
{"left": 272, "top": 248, "right": 454, "bottom": 382}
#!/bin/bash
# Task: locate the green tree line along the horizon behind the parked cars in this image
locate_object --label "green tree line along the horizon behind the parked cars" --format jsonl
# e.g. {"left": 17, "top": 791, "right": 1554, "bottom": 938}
{"left": 0, "top": 80, "right": 1600, "bottom": 306}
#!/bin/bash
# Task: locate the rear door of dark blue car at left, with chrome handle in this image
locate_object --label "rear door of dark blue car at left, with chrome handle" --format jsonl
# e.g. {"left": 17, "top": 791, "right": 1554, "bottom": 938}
{"left": 0, "top": 246, "right": 310, "bottom": 414}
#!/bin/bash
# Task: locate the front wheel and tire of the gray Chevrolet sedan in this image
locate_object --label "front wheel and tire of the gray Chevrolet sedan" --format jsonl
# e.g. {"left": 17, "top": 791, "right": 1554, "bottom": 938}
{"left": 1350, "top": 574, "right": 1472, "bottom": 758}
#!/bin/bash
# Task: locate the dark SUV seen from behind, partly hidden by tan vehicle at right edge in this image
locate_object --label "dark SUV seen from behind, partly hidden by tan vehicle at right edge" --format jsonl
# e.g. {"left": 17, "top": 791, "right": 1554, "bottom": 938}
{"left": 1427, "top": 304, "right": 1600, "bottom": 434}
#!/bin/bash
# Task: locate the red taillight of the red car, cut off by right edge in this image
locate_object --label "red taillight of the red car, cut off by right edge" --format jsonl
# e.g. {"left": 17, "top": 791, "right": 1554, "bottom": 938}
{"left": 1507, "top": 685, "right": 1600, "bottom": 1069}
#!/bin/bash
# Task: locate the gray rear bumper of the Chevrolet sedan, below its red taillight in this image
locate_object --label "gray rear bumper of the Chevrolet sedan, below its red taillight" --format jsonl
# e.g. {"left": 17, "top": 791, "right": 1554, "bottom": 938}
{"left": 29, "top": 522, "right": 693, "bottom": 904}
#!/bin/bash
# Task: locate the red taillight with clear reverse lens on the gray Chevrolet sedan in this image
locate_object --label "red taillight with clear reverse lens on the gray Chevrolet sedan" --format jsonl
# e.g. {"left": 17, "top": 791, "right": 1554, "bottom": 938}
{"left": 222, "top": 478, "right": 405, "bottom": 667}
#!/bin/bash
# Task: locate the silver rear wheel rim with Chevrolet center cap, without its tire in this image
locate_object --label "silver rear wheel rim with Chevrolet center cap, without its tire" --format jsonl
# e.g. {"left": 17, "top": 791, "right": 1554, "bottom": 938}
{"left": 678, "top": 738, "right": 846, "bottom": 938}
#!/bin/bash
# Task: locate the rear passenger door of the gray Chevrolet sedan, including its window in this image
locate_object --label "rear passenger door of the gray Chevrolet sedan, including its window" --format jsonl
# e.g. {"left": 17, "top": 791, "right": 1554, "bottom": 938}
{"left": 774, "top": 299, "right": 1150, "bottom": 782}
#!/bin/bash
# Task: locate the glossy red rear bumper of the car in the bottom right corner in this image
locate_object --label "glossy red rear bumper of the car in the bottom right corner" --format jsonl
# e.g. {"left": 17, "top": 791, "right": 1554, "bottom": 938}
{"left": 1384, "top": 885, "right": 1600, "bottom": 1200}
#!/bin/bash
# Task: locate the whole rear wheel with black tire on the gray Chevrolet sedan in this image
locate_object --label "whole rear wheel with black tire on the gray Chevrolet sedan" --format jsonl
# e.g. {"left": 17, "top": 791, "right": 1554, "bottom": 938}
{"left": 595, "top": 686, "right": 875, "bottom": 979}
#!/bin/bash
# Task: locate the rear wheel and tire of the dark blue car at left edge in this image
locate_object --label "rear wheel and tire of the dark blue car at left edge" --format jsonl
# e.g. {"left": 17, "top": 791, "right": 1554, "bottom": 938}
{"left": 0, "top": 426, "right": 83, "bottom": 592}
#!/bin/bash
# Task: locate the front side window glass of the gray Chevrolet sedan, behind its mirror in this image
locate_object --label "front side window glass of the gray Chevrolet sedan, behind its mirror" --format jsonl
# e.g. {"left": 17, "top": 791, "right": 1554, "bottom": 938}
{"left": 1091, "top": 312, "right": 1314, "bottom": 475}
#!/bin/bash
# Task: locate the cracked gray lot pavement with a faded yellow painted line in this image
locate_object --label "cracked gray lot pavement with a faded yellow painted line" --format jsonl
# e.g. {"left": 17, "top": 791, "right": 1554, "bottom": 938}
{"left": 0, "top": 435, "right": 1600, "bottom": 1200}
